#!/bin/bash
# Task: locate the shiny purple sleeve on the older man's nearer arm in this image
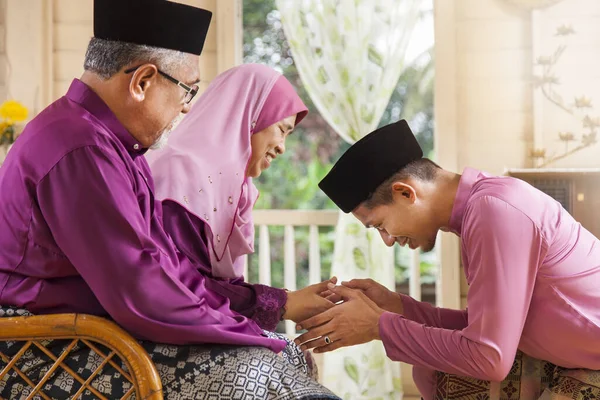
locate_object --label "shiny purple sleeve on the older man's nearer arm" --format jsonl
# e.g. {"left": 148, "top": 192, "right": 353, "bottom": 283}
{"left": 36, "top": 146, "right": 282, "bottom": 351}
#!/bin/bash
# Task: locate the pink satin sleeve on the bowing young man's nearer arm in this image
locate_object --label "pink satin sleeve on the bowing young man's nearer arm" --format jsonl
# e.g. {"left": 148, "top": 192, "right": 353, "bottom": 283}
{"left": 379, "top": 197, "right": 547, "bottom": 381}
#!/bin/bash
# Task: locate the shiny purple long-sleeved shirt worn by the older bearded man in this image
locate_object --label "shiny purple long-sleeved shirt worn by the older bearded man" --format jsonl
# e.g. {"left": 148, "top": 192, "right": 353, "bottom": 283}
{"left": 0, "top": 80, "right": 285, "bottom": 351}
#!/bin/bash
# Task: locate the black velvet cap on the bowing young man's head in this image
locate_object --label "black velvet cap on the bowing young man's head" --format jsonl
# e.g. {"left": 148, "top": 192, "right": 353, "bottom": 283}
{"left": 319, "top": 120, "right": 423, "bottom": 213}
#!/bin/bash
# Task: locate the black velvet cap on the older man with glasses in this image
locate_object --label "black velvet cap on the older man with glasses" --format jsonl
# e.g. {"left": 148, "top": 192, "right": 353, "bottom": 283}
{"left": 94, "top": 0, "right": 212, "bottom": 55}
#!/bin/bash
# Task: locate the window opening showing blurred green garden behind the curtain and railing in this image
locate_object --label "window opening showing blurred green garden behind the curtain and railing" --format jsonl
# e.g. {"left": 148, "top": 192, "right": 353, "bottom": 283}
{"left": 243, "top": 0, "right": 437, "bottom": 302}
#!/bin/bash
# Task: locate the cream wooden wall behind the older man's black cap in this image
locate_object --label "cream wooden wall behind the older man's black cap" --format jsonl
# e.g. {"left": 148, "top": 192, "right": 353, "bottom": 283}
{"left": 0, "top": 0, "right": 241, "bottom": 116}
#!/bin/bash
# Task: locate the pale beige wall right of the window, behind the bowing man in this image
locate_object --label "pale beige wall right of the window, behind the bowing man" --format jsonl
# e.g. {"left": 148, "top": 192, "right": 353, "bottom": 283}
{"left": 435, "top": 0, "right": 600, "bottom": 307}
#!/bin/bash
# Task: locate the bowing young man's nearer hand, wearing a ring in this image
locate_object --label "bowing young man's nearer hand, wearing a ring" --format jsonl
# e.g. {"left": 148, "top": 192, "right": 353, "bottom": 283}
{"left": 295, "top": 284, "right": 384, "bottom": 353}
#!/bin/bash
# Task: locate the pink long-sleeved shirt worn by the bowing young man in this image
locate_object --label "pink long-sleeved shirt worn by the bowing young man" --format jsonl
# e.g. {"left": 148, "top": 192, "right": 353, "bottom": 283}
{"left": 380, "top": 169, "right": 600, "bottom": 381}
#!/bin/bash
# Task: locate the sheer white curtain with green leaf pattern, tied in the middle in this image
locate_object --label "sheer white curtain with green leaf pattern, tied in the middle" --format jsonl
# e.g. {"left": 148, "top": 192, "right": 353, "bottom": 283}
{"left": 277, "top": 0, "right": 420, "bottom": 399}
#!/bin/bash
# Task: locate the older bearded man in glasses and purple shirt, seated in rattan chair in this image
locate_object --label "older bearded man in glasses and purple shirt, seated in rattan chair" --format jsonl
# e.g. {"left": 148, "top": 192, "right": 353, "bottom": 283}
{"left": 0, "top": 0, "right": 336, "bottom": 399}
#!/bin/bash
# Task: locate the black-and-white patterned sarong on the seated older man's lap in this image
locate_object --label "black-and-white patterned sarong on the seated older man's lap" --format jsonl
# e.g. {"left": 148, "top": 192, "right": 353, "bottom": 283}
{"left": 0, "top": 307, "right": 339, "bottom": 400}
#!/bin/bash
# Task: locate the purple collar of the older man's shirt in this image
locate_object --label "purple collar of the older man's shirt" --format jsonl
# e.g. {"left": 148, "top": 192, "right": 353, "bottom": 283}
{"left": 66, "top": 79, "right": 146, "bottom": 158}
